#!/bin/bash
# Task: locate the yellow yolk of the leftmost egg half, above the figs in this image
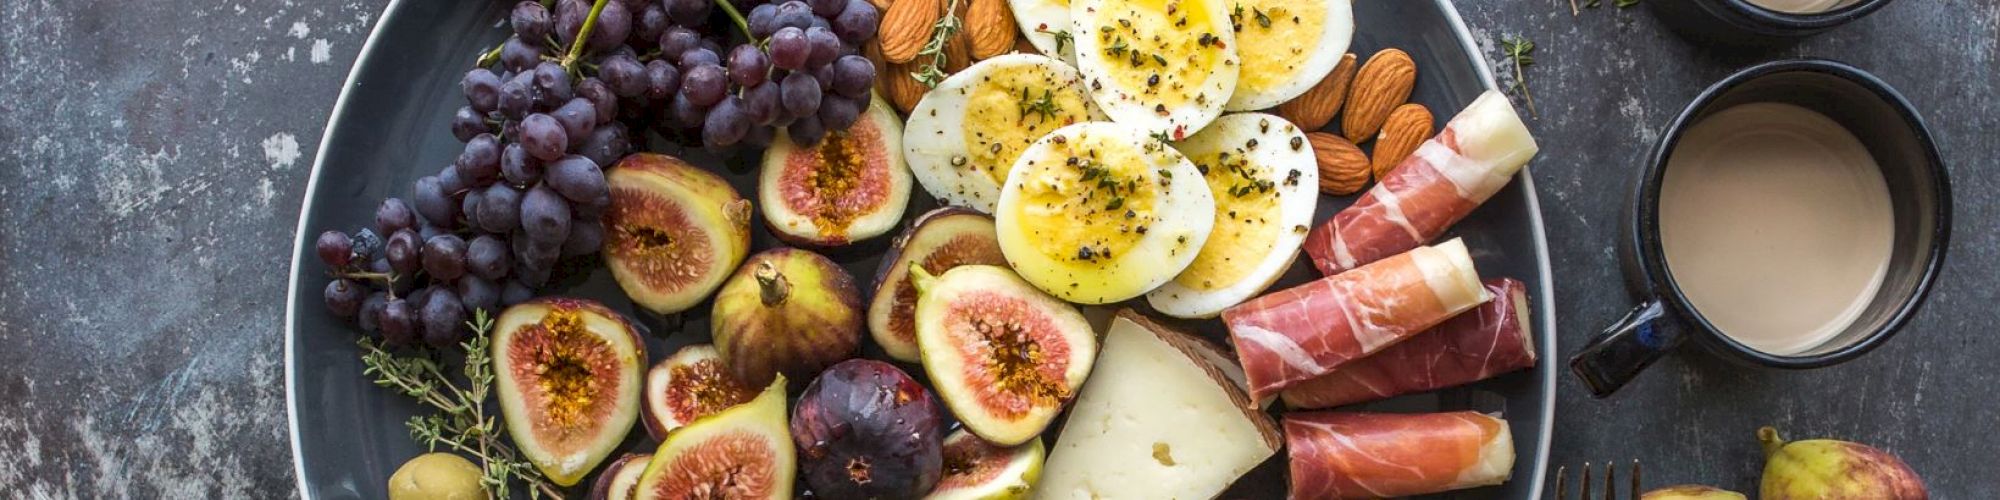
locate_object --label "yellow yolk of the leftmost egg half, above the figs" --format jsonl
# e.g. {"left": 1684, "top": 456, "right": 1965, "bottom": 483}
{"left": 962, "top": 68, "right": 1086, "bottom": 186}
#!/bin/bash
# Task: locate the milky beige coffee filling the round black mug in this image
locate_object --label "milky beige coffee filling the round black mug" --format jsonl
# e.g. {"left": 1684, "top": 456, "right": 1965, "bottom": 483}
{"left": 1660, "top": 102, "right": 1896, "bottom": 356}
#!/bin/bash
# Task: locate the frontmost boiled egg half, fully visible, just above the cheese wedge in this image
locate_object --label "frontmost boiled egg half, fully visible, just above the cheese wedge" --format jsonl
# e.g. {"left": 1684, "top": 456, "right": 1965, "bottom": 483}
{"left": 994, "top": 122, "right": 1216, "bottom": 304}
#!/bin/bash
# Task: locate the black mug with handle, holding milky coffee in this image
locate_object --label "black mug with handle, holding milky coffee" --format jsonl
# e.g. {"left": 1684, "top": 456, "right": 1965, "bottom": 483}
{"left": 1570, "top": 60, "right": 1952, "bottom": 398}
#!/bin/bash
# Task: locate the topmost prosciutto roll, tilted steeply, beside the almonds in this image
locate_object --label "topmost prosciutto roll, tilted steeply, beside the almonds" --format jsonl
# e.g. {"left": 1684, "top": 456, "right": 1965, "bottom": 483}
{"left": 1306, "top": 90, "right": 1540, "bottom": 276}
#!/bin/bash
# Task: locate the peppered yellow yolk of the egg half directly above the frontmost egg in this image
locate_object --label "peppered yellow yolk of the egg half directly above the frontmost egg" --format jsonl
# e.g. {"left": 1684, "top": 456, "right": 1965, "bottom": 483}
{"left": 1090, "top": 0, "right": 1228, "bottom": 116}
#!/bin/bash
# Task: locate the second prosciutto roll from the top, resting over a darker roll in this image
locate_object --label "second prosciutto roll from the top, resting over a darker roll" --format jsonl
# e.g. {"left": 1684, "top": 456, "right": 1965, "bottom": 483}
{"left": 1222, "top": 240, "right": 1490, "bottom": 400}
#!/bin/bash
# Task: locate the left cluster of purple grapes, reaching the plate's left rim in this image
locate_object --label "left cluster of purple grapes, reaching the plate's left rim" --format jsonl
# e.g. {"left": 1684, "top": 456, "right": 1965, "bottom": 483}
{"left": 316, "top": 2, "right": 632, "bottom": 348}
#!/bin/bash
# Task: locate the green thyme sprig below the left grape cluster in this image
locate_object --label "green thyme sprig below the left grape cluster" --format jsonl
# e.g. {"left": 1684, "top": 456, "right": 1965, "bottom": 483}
{"left": 356, "top": 310, "right": 562, "bottom": 500}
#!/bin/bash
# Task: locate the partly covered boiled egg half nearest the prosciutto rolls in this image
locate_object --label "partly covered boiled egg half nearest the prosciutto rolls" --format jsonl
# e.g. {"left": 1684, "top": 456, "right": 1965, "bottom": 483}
{"left": 1146, "top": 112, "right": 1320, "bottom": 318}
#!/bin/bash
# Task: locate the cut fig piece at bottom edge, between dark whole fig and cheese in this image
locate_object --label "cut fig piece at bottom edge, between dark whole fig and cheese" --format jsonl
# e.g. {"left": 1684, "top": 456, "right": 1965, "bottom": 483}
{"left": 924, "top": 428, "right": 1044, "bottom": 500}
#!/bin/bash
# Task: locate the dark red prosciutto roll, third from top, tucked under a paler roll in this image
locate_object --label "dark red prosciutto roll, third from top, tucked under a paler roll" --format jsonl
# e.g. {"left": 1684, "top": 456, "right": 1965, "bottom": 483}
{"left": 1280, "top": 278, "right": 1534, "bottom": 408}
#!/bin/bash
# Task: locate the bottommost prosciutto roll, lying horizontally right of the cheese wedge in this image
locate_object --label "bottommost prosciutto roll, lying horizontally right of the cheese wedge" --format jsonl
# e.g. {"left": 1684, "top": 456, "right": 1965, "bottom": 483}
{"left": 1284, "top": 412, "right": 1514, "bottom": 500}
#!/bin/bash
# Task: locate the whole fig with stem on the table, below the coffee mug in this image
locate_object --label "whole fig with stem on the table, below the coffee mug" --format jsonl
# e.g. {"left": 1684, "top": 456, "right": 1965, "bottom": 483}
{"left": 1756, "top": 426, "right": 1930, "bottom": 500}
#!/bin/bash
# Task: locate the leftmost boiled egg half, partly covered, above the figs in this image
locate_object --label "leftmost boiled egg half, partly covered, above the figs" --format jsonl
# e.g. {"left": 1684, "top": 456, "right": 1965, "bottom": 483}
{"left": 902, "top": 54, "right": 1092, "bottom": 212}
